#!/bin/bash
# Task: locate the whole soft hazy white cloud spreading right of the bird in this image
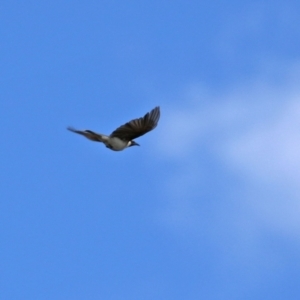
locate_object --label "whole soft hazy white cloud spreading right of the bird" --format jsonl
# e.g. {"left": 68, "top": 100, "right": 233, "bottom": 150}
{"left": 157, "top": 61, "right": 300, "bottom": 244}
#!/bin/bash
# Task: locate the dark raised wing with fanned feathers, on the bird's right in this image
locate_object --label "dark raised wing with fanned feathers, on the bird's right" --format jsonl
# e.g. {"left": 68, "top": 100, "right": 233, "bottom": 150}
{"left": 110, "top": 106, "right": 160, "bottom": 141}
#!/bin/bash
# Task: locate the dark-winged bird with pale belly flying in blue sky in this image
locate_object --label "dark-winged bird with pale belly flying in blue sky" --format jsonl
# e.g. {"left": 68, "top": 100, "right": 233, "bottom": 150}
{"left": 67, "top": 106, "right": 160, "bottom": 151}
